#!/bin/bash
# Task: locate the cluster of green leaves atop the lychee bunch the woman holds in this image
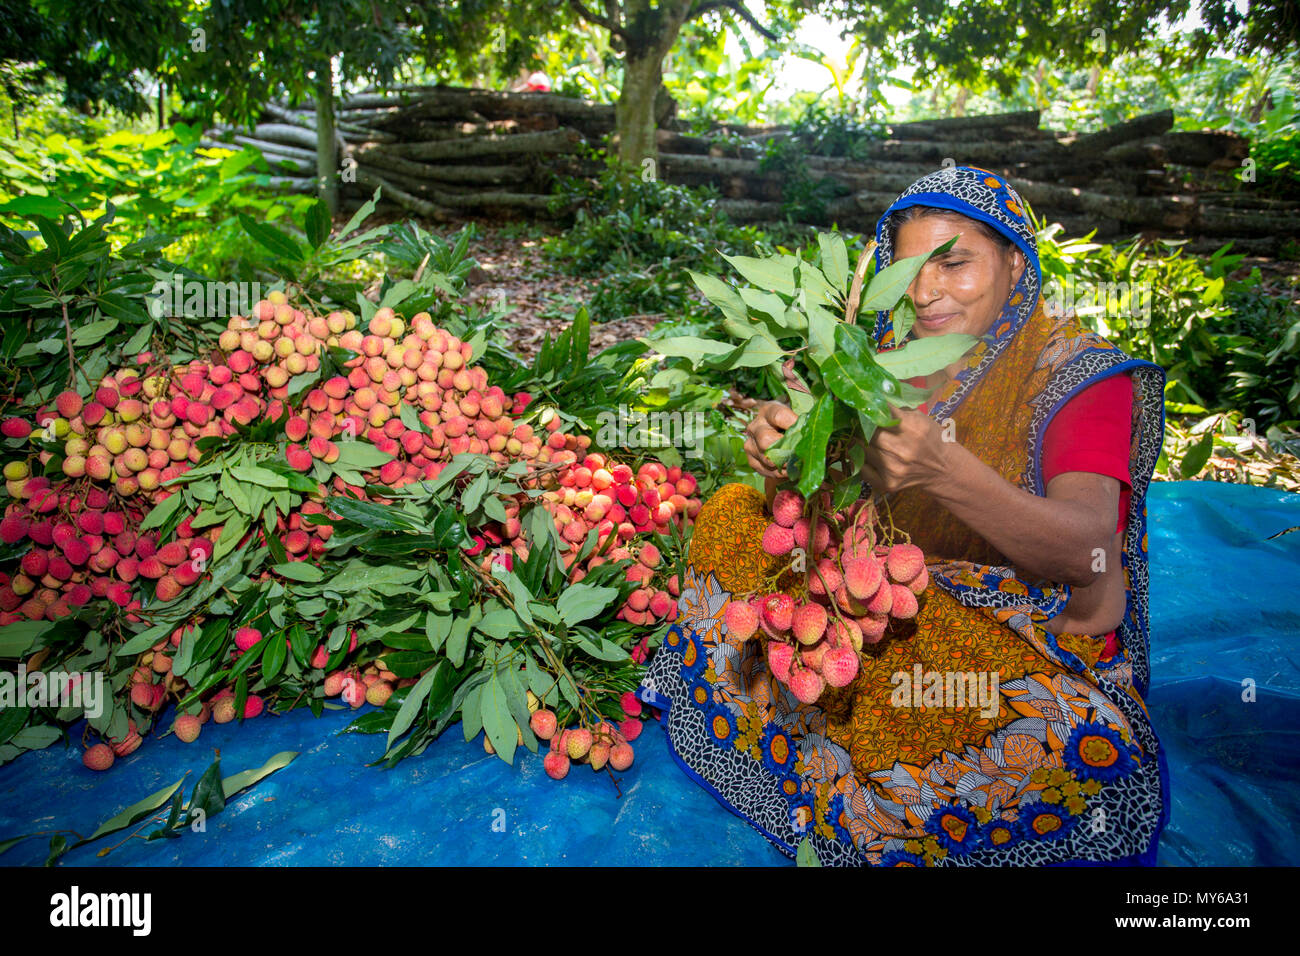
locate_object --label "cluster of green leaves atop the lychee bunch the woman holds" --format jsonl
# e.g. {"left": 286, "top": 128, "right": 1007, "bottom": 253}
{"left": 640, "top": 233, "right": 978, "bottom": 499}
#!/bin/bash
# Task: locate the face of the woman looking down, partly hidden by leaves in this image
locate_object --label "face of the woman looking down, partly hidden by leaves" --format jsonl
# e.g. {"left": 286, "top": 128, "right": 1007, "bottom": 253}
{"left": 894, "top": 213, "right": 1024, "bottom": 338}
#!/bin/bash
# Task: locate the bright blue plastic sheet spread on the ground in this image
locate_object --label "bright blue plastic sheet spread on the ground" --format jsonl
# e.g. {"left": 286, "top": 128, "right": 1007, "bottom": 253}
{"left": 0, "top": 481, "right": 1300, "bottom": 866}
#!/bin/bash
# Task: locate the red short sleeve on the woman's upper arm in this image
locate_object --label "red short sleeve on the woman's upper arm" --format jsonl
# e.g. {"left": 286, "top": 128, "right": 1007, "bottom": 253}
{"left": 1043, "top": 375, "right": 1134, "bottom": 532}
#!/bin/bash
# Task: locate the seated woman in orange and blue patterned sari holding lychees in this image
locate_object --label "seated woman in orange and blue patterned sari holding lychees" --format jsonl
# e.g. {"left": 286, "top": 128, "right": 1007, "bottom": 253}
{"left": 638, "top": 166, "right": 1169, "bottom": 865}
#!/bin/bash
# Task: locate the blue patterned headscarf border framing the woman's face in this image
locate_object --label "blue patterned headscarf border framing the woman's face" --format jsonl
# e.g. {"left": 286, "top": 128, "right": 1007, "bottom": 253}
{"left": 875, "top": 166, "right": 1043, "bottom": 351}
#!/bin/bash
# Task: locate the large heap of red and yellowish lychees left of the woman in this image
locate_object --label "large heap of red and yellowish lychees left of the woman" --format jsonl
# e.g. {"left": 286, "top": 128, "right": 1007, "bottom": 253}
{"left": 0, "top": 293, "right": 701, "bottom": 775}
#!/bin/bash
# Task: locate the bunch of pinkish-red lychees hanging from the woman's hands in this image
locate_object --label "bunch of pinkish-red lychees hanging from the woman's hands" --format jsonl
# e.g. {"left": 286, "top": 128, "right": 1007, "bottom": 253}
{"left": 725, "top": 489, "right": 930, "bottom": 704}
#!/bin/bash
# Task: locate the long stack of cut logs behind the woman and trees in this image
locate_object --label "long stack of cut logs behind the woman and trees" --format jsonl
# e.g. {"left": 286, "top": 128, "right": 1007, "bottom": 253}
{"left": 205, "top": 86, "right": 1300, "bottom": 254}
